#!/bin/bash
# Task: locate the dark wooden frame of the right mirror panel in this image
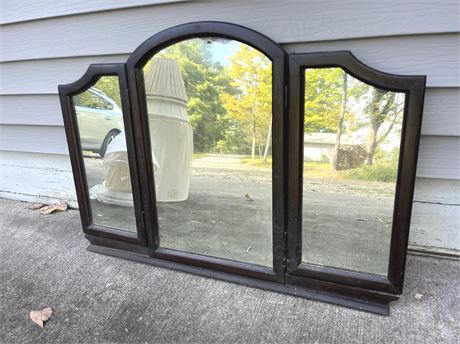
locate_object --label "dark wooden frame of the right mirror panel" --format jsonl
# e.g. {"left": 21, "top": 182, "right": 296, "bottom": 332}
{"left": 287, "top": 51, "right": 426, "bottom": 307}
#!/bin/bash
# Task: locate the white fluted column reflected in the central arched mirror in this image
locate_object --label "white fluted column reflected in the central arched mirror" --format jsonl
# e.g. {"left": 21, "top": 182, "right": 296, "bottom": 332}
{"left": 144, "top": 58, "right": 193, "bottom": 202}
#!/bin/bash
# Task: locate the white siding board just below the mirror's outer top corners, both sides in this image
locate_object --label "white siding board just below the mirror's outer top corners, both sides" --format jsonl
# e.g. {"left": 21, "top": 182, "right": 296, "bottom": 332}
{"left": 0, "top": 88, "right": 460, "bottom": 136}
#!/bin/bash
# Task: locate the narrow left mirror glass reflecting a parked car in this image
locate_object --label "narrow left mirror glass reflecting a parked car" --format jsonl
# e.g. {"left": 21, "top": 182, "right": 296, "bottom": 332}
{"left": 73, "top": 76, "right": 136, "bottom": 232}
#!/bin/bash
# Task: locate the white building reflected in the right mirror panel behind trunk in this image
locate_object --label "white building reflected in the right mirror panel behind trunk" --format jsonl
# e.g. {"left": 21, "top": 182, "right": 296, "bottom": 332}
{"left": 303, "top": 133, "right": 362, "bottom": 162}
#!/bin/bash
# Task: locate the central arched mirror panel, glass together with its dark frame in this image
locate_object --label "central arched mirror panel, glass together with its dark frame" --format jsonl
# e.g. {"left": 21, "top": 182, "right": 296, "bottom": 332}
{"left": 124, "top": 22, "right": 286, "bottom": 280}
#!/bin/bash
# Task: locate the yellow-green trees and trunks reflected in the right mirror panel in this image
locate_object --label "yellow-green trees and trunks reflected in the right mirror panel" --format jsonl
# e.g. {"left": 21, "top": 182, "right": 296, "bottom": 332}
{"left": 304, "top": 68, "right": 402, "bottom": 170}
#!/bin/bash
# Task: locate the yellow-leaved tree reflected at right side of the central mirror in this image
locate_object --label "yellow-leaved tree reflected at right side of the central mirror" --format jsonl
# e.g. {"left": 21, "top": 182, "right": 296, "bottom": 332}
{"left": 221, "top": 44, "right": 272, "bottom": 159}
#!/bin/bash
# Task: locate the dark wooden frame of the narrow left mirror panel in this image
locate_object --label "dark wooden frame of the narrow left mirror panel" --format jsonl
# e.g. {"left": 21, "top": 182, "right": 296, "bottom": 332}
{"left": 58, "top": 63, "right": 146, "bottom": 245}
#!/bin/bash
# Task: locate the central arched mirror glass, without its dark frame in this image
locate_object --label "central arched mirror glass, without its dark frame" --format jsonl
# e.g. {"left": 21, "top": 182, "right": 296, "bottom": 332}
{"left": 143, "top": 37, "right": 273, "bottom": 267}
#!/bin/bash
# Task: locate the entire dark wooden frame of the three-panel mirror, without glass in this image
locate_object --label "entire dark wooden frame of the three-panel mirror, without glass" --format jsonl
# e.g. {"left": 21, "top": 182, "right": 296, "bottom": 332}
{"left": 59, "top": 21, "right": 426, "bottom": 315}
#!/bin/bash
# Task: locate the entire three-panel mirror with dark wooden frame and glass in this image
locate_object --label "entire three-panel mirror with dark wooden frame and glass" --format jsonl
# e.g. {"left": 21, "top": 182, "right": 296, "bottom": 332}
{"left": 59, "top": 22, "right": 425, "bottom": 314}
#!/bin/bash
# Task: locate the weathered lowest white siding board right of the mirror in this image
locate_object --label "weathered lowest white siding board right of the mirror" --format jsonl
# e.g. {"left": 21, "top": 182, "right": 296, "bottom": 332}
{"left": 409, "top": 202, "right": 460, "bottom": 251}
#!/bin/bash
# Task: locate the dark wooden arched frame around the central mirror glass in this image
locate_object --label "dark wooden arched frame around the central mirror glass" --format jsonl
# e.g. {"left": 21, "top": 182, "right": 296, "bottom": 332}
{"left": 126, "top": 22, "right": 287, "bottom": 282}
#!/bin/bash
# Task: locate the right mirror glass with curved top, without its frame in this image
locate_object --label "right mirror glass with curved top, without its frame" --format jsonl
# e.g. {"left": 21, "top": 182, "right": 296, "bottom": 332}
{"left": 302, "top": 68, "right": 405, "bottom": 275}
